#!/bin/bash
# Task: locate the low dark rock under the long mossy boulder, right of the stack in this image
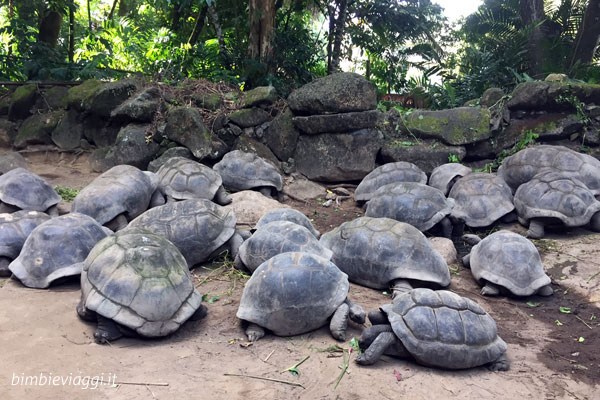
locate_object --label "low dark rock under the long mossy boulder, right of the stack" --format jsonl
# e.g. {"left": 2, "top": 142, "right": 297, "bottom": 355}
{"left": 381, "top": 141, "right": 467, "bottom": 174}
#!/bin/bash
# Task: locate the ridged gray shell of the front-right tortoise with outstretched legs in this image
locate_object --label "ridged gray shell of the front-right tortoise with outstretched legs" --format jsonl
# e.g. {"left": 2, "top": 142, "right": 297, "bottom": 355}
{"left": 381, "top": 289, "right": 506, "bottom": 369}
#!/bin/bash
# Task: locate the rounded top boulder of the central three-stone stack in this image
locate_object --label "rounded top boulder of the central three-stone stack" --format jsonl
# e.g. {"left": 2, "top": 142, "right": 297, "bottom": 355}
{"left": 288, "top": 72, "right": 377, "bottom": 115}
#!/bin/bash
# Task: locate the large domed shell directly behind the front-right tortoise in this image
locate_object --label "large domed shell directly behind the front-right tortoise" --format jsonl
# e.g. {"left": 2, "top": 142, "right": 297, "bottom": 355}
{"left": 320, "top": 217, "right": 450, "bottom": 289}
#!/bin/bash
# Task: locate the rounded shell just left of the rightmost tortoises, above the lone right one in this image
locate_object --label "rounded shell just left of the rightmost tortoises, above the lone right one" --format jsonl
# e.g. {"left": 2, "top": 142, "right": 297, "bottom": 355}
{"left": 448, "top": 172, "right": 515, "bottom": 228}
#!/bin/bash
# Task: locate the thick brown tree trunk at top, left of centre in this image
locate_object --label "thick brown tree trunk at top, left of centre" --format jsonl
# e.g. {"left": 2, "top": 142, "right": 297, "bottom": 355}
{"left": 248, "top": 0, "right": 275, "bottom": 68}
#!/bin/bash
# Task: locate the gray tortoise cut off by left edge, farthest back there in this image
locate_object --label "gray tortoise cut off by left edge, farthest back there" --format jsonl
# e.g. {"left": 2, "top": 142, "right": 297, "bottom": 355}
{"left": 0, "top": 168, "right": 60, "bottom": 216}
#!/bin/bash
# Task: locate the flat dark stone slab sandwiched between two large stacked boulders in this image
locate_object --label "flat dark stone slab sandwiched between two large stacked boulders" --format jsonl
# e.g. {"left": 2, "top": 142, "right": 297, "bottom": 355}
{"left": 293, "top": 110, "right": 382, "bottom": 135}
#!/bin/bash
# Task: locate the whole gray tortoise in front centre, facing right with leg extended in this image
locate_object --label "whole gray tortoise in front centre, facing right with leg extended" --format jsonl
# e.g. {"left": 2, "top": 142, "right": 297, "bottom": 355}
{"left": 237, "top": 252, "right": 365, "bottom": 342}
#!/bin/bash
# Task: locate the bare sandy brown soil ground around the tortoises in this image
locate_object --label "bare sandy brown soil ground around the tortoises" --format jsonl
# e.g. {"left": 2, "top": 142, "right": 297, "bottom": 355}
{"left": 0, "top": 152, "right": 600, "bottom": 400}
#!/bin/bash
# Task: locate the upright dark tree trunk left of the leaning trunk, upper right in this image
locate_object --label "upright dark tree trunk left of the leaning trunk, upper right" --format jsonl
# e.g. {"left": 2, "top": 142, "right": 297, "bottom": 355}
{"left": 520, "top": 0, "right": 546, "bottom": 77}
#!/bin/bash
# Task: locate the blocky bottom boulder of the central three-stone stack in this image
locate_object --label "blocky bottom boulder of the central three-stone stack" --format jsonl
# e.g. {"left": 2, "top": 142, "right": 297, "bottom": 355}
{"left": 294, "top": 129, "right": 383, "bottom": 182}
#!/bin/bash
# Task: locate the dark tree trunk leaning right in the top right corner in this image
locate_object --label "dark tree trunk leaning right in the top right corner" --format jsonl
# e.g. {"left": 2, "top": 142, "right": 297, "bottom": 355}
{"left": 570, "top": 0, "right": 600, "bottom": 67}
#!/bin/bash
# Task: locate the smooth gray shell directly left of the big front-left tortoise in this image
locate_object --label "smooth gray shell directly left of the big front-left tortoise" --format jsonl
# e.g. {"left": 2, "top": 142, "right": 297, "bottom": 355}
{"left": 8, "top": 213, "right": 112, "bottom": 289}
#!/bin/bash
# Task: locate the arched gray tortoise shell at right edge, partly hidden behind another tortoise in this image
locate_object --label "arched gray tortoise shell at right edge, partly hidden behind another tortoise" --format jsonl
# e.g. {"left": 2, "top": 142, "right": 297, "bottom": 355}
{"left": 498, "top": 145, "right": 600, "bottom": 195}
